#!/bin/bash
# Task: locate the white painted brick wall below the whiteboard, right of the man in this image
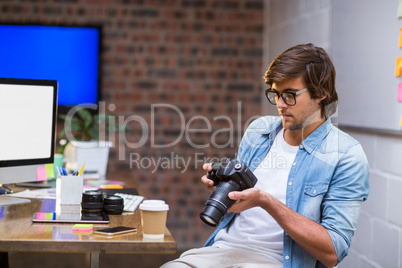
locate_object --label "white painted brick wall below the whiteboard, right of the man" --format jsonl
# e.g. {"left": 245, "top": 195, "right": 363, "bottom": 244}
{"left": 339, "top": 131, "right": 402, "bottom": 268}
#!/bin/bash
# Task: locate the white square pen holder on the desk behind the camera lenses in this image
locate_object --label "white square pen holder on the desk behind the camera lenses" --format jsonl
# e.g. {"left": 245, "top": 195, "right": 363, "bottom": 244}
{"left": 56, "top": 175, "right": 84, "bottom": 205}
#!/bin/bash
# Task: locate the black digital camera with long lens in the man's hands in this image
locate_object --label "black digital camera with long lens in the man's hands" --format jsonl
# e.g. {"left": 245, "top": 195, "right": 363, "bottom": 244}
{"left": 200, "top": 158, "right": 257, "bottom": 227}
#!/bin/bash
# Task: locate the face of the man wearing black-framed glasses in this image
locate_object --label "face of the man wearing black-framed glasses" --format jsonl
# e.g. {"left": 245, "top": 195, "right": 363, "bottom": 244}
{"left": 272, "top": 77, "right": 322, "bottom": 130}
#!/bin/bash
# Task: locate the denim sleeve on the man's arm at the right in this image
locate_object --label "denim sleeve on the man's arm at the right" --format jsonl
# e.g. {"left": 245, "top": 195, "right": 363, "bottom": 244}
{"left": 321, "top": 144, "right": 369, "bottom": 262}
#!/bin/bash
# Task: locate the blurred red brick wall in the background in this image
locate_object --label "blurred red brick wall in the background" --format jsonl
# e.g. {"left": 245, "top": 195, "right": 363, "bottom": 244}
{"left": 0, "top": 0, "right": 263, "bottom": 249}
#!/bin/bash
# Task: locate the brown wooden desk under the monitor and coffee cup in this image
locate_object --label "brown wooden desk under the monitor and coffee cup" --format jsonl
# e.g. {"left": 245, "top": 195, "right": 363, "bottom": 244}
{"left": 0, "top": 199, "right": 176, "bottom": 267}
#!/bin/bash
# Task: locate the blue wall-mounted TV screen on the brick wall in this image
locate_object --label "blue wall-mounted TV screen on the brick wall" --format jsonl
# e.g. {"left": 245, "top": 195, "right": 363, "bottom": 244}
{"left": 0, "top": 24, "right": 101, "bottom": 111}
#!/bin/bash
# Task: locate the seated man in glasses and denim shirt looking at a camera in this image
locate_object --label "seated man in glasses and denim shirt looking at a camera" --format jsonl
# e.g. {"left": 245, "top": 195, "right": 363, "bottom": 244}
{"left": 163, "top": 44, "right": 369, "bottom": 268}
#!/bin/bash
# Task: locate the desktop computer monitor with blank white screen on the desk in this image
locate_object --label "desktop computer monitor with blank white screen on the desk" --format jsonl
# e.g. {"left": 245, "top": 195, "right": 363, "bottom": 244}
{"left": 0, "top": 78, "right": 58, "bottom": 205}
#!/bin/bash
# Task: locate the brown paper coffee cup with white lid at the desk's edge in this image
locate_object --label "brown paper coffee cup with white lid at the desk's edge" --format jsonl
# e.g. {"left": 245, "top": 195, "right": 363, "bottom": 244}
{"left": 140, "top": 200, "right": 169, "bottom": 239}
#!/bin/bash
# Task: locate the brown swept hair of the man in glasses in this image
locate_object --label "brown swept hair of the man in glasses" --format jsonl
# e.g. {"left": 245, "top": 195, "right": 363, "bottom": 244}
{"left": 264, "top": 43, "right": 338, "bottom": 117}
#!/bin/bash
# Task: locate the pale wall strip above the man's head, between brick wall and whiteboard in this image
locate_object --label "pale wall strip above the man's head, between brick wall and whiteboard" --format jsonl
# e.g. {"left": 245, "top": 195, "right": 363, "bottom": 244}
{"left": 262, "top": 0, "right": 332, "bottom": 115}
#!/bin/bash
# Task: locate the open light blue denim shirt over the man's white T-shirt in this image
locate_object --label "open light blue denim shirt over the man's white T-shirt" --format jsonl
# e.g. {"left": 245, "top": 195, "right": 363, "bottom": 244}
{"left": 205, "top": 116, "right": 369, "bottom": 268}
